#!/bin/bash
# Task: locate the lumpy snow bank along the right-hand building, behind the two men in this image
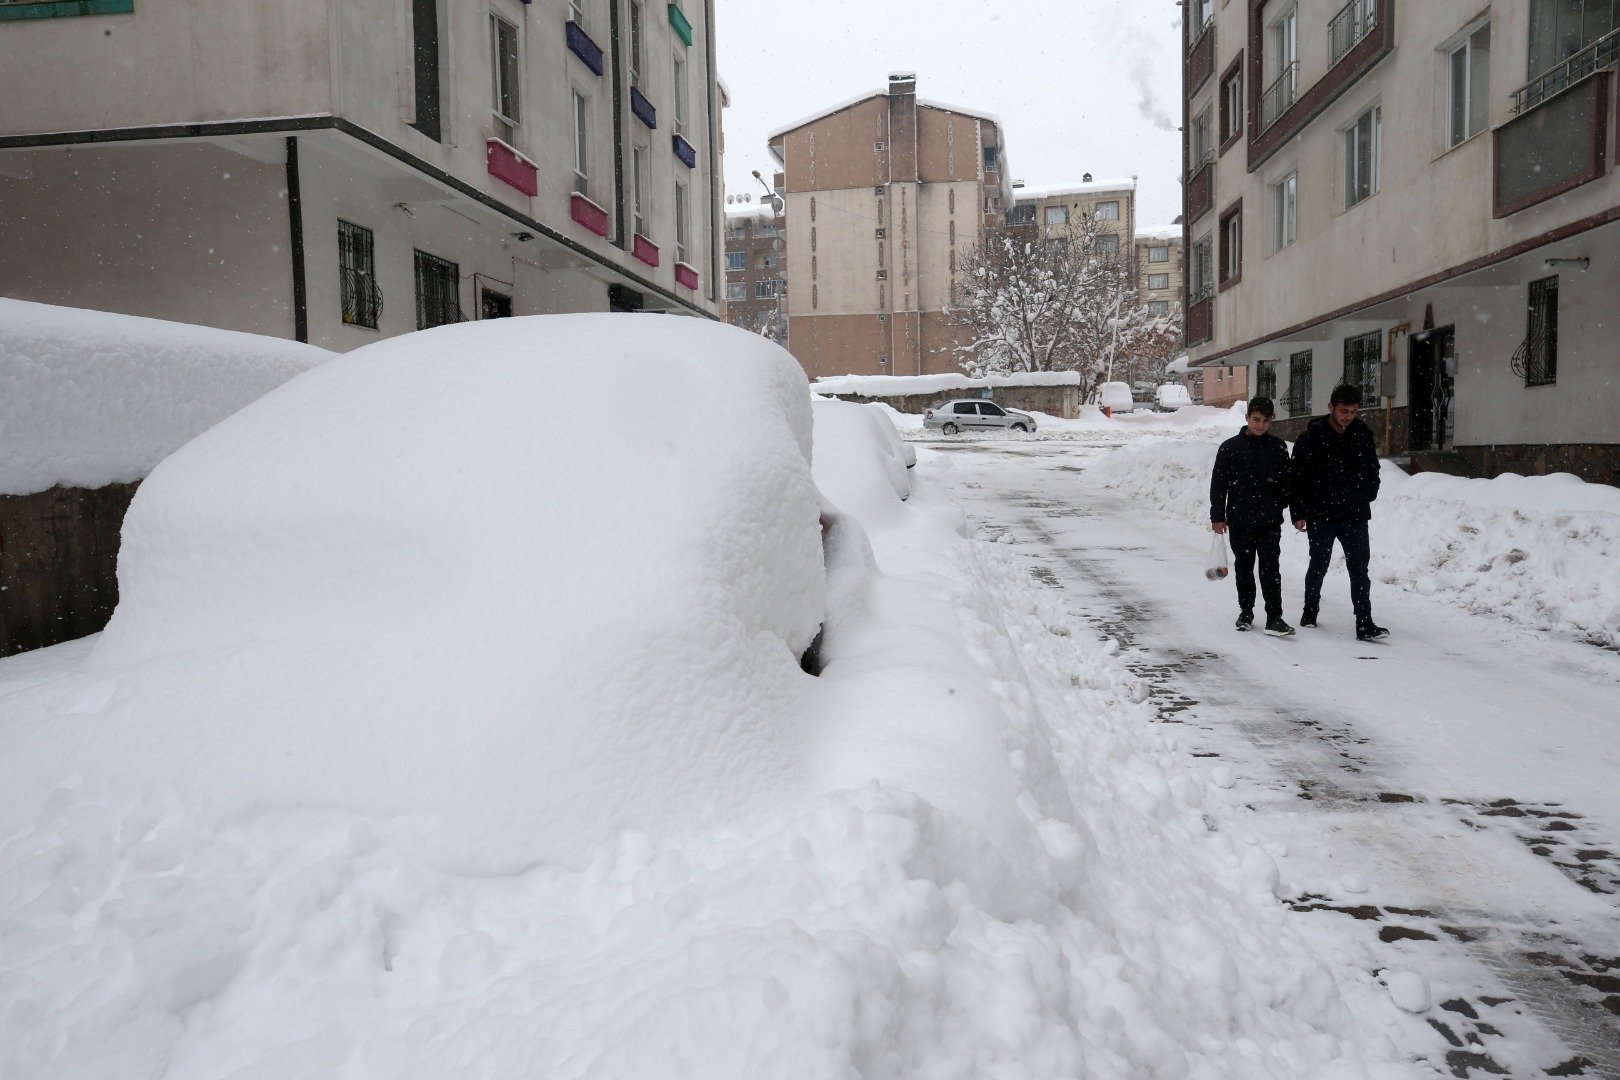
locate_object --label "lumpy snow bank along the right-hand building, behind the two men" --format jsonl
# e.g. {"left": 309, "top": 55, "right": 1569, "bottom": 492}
{"left": 1089, "top": 433, "right": 1620, "bottom": 648}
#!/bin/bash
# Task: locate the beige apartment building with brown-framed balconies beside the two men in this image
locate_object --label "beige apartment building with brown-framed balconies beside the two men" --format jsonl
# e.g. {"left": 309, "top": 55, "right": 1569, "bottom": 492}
{"left": 1184, "top": 0, "right": 1620, "bottom": 483}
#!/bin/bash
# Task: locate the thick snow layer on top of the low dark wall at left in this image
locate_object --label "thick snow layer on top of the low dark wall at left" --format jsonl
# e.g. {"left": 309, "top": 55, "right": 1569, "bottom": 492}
{"left": 0, "top": 298, "right": 332, "bottom": 495}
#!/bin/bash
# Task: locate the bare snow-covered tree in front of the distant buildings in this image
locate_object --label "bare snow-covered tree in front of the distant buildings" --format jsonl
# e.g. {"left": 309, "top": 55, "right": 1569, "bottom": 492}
{"left": 948, "top": 219, "right": 1179, "bottom": 392}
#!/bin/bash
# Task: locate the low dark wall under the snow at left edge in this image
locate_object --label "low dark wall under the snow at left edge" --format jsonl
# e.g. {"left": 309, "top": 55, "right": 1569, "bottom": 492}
{"left": 0, "top": 484, "right": 136, "bottom": 656}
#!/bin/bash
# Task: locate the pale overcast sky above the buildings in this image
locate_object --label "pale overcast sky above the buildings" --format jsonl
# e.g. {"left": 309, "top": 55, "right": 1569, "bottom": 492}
{"left": 716, "top": 0, "right": 1181, "bottom": 227}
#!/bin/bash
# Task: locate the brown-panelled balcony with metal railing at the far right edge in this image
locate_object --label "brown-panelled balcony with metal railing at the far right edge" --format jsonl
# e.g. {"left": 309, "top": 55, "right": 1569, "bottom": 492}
{"left": 1492, "top": 69, "right": 1614, "bottom": 219}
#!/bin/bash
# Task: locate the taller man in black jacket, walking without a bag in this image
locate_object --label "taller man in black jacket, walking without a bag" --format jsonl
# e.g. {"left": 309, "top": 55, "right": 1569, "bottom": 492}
{"left": 1294, "top": 385, "right": 1390, "bottom": 641}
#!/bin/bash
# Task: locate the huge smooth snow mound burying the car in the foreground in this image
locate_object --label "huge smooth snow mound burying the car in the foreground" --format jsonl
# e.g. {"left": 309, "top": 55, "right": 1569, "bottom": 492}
{"left": 0, "top": 316, "right": 825, "bottom": 873}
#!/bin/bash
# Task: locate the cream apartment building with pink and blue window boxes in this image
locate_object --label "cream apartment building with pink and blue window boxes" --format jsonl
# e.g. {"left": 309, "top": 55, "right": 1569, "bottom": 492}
{"left": 0, "top": 0, "right": 723, "bottom": 350}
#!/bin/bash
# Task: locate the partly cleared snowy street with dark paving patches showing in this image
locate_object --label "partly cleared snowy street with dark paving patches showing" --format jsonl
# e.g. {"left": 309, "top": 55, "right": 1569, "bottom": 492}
{"left": 919, "top": 434, "right": 1620, "bottom": 1077}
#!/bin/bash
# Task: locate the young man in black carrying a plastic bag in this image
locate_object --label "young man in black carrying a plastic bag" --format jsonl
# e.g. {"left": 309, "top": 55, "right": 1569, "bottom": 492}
{"left": 1210, "top": 397, "right": 1294, "bottom": 638}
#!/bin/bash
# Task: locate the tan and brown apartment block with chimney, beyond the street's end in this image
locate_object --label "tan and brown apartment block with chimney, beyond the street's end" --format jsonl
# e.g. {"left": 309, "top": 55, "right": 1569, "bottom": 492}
{"left": 770, "top": 74, "right": 1013, "bottom": 379}
